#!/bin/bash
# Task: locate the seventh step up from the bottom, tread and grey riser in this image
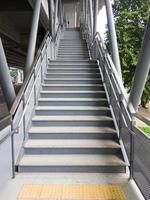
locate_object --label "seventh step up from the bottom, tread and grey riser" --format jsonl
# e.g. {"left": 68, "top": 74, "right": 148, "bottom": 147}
{"left": 40, "top": 90, "right": 106, "bottom": 98}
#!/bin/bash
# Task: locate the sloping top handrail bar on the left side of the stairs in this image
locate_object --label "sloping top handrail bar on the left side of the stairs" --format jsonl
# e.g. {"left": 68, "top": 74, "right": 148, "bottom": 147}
{"left": 10, "top": 32, "right": 51, "bottom": 117}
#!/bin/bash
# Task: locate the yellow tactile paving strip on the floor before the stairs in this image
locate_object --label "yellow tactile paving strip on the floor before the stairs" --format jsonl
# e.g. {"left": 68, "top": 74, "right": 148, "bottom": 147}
{"left": 18, "top": 184, "right": 126, "bottom": 200}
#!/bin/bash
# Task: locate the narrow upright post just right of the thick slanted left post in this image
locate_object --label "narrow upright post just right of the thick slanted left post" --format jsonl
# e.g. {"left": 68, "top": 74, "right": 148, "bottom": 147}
{"left": 48, "top": 0, "right": 54, "bottom": 39}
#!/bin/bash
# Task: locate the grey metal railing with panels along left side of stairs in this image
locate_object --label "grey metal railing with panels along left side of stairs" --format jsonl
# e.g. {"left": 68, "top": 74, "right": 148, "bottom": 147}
{"left": 0, "top": 23, "right": 63, "bottom": 187}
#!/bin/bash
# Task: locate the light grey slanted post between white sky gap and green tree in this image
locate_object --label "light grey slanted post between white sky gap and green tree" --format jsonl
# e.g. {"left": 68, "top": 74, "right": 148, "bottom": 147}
{"left": 105, "top": 0, "right": 122, "bottom": 77}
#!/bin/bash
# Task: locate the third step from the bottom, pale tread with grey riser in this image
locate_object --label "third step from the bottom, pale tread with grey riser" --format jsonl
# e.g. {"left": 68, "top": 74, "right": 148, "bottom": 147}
{"left": 29, "top": 126, "right": 117, "bottom": 140}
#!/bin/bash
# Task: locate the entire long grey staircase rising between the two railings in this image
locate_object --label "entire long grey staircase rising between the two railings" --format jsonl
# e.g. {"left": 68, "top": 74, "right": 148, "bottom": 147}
{"left": 18, "top": 29, "right": 126, "bottom": 173}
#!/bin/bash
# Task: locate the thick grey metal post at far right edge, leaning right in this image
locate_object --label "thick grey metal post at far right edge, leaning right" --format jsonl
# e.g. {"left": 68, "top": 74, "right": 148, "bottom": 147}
{"left": 129, "top": 18, "right": 150, "bottom": 111}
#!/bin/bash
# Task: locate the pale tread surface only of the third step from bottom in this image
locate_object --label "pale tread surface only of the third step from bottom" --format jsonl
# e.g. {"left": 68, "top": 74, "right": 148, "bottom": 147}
{"left": 29, "top": 126, "right": 116, "bottom": 134}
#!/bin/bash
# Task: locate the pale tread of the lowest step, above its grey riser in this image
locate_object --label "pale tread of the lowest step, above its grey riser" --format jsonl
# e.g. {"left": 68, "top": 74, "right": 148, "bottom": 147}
{"left": 19, "top": 154, "right": 126, "bottom": 167}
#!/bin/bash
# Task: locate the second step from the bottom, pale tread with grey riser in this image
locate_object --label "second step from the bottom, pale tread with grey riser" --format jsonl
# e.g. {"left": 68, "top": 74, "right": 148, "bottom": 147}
{"left": 24, "top": 139, "right": 121, "bottom": 155}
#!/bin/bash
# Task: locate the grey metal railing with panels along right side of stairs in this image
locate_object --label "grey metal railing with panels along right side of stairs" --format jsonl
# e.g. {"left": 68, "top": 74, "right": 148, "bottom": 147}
{"left": 81, "top": 24, "right": 150, "bottom": 199}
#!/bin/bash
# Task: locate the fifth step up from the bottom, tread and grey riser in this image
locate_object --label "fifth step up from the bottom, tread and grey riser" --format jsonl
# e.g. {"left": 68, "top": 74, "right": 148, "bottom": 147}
{"left": 35, "top": 106, "right": 111, "bottom": 116}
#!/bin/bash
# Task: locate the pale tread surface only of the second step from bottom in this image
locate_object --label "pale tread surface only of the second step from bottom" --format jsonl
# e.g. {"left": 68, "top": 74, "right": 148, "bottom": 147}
{"left": 24, "top": 139, "right": 120, "bottom": 148}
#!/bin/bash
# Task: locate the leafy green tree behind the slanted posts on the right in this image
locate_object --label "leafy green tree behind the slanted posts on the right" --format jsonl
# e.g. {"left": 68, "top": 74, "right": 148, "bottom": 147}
{"left": 113, "top": 0, "right": 150, "bottom": 106}
